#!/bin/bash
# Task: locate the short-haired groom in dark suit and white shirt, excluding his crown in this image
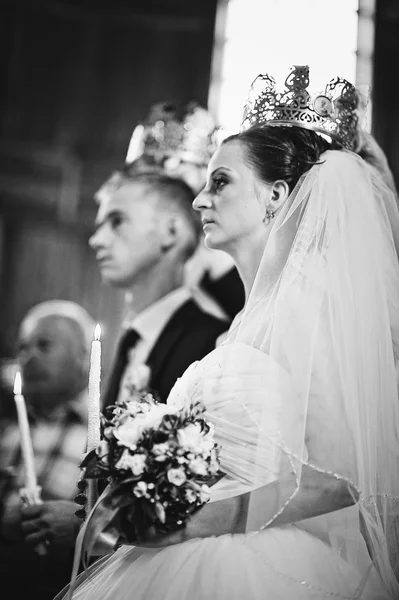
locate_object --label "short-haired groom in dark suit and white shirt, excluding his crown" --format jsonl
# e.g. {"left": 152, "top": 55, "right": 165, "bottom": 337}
{"left": 90, "top": 166, "right": 228, "bottom": 406}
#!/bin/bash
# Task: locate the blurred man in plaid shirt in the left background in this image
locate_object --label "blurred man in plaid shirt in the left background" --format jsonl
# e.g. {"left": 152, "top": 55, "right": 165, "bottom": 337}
{"left": 0, "top": 300, "right": 94, "bottom": 600}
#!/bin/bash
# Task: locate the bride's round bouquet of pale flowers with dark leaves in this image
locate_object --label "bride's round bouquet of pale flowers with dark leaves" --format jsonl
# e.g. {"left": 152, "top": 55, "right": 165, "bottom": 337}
{"left": 85, "top": 376, "right": 219, "bottom": 543}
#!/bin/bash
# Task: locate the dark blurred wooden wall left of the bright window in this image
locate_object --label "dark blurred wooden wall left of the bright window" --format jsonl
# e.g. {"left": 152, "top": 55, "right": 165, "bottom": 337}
{"left": 0, "top": 0, "right": 216, "bottom": 382}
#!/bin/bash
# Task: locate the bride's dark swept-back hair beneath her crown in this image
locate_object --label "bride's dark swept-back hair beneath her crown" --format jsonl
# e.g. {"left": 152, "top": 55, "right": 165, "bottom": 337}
{"left": 222, "top": 125, "right": 342, "bottom": 191}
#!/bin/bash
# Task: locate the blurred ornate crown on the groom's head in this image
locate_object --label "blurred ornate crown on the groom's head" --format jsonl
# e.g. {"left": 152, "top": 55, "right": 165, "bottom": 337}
{"left": 126, "top": 102, "right": 218, "bottom": 166}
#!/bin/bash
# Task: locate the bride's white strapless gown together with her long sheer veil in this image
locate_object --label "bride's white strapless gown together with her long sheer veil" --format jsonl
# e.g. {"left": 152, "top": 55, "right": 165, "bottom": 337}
{"left": 57, "top": 151, "right": 399, "bottom": 600}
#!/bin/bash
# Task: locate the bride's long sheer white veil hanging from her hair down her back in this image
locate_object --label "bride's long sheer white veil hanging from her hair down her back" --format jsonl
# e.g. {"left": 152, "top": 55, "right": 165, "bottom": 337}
{"left": 202, "top": 150, "right": 399, "bottom": 596}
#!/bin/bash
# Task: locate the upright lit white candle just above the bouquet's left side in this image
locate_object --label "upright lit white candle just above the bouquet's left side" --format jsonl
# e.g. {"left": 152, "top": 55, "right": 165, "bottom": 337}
{"left": 87, "top": 323, "right": 101, "bottom": 452}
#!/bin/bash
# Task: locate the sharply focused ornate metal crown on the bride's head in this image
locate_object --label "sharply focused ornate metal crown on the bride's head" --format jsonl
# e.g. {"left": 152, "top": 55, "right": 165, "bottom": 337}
{"left": 241, "top": 65, "right": 359, "bottom": 150}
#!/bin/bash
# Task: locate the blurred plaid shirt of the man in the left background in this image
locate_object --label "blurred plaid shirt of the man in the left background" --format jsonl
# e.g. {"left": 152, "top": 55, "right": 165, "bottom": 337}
{"left": 0, "top": 392, "right": 87, "bottom": 504}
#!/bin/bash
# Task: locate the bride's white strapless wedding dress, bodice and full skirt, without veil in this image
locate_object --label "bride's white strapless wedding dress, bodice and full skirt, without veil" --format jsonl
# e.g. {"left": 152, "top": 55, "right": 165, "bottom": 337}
{"left": 57, "top": 343, "right": 391, "bottom": 600}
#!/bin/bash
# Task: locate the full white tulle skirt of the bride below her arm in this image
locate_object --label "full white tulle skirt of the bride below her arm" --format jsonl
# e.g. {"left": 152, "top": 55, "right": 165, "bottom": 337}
{"left": 56, "top": 526, "right": 392, "bottom": 600}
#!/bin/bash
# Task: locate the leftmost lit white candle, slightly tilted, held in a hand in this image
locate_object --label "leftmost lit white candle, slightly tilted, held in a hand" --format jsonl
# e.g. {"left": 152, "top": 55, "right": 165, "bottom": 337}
{"left": 14, "top": 371, "right": 37, "bottom": 495}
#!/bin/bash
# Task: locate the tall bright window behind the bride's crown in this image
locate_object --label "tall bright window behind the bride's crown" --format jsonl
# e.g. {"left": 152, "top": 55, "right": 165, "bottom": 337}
{"left": 208, "top": 0, "right": 375, "bottom": 135}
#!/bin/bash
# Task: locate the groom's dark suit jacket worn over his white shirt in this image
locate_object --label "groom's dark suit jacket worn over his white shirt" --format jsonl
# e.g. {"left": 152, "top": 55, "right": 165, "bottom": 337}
{"left": 103, "top": 300, "right": 229, "bottom": 407}
